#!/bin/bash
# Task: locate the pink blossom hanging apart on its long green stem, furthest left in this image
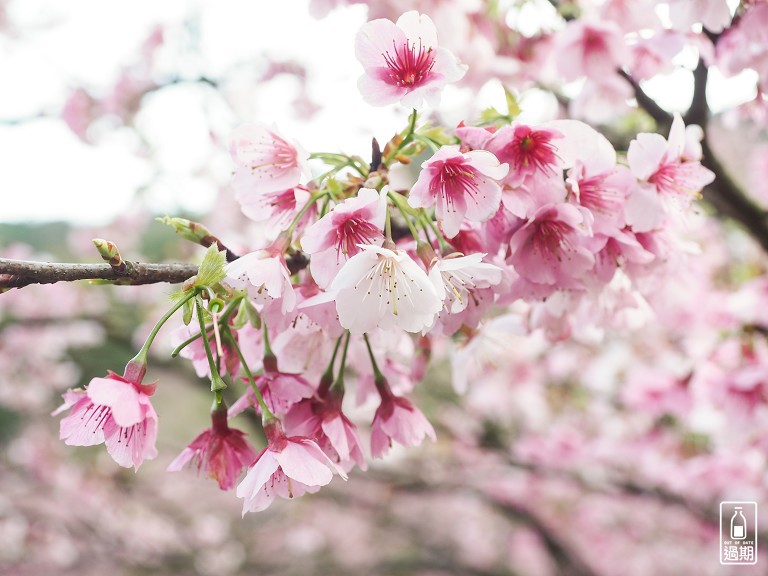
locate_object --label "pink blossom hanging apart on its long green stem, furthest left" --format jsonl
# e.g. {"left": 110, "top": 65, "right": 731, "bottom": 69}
{"left": 53, "top": 372, "right": 157, "bottom": 470}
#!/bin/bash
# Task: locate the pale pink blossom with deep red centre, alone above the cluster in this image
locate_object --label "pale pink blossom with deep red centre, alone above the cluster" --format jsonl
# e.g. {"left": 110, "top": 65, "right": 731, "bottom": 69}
{"left": 355, "top": 10, "right": 467, "bottom": 108}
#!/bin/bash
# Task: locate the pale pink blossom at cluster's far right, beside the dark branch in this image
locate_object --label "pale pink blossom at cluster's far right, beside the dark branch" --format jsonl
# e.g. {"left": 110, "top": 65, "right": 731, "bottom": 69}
{"left": 625, "top": 113, "right": 715, "bottom": 232}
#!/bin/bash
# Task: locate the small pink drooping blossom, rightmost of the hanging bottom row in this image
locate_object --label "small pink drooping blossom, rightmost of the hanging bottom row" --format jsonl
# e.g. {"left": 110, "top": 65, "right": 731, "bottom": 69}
{"left": 371, "top": 392, "right": 437, "bottom": 458}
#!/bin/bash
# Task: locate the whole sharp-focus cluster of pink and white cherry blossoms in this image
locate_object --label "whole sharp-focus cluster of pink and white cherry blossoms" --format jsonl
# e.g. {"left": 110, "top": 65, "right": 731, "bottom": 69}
{"left": 52, "top": 7, "right": 713, "bottom": 513}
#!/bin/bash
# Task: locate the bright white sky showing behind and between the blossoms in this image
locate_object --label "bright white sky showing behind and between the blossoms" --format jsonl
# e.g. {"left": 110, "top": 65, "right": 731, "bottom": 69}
{"left": 0, "top": 0, "right": 753, "bottom": 225}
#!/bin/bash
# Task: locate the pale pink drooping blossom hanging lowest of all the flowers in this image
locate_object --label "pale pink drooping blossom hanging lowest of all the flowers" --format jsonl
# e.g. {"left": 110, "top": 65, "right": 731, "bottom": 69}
{"left": 237, "top": 420, "right": 347, "bottom": 515}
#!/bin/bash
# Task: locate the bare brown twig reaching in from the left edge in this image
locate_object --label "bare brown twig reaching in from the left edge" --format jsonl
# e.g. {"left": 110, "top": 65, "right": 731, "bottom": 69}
{"left": 0, "top": 258, "right": 197, "bottom": 290}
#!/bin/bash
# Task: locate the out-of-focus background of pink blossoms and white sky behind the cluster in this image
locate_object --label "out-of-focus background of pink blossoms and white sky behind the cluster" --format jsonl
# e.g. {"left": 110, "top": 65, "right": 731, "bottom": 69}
{"left": 0, "top": 0, "right": 768, "bottom": 576}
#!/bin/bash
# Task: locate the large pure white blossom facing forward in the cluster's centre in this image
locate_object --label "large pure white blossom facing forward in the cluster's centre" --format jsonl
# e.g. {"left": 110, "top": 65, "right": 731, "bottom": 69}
{"left": 330, "top": 245, "right": 443, "bottom": 335}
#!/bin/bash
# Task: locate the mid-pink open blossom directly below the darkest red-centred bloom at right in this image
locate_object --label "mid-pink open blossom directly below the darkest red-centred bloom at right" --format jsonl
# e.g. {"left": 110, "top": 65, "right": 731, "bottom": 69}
{"left": 509, "top": 204, "right": 595, "bottom": 288}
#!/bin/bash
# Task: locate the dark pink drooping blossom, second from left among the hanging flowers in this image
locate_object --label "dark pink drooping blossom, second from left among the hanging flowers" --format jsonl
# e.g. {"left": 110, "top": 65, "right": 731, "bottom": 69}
{"left": 168, "top": 405, "right": 256, "bottom": 490}
